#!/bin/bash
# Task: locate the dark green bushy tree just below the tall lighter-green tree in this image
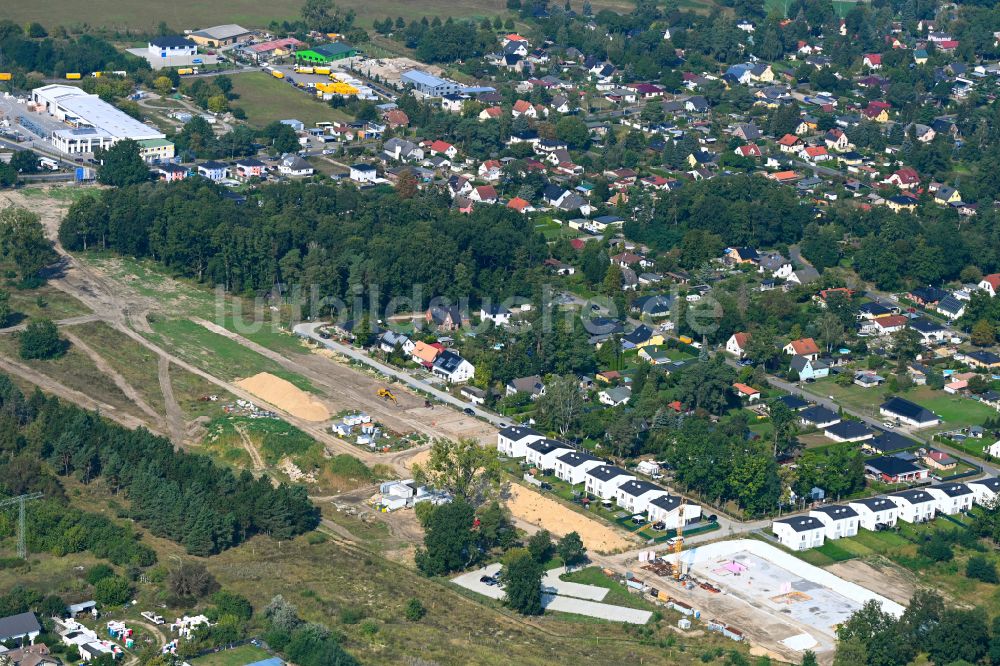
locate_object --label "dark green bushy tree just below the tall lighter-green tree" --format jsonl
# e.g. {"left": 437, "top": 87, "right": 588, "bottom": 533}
{"left": 415, "top": 497, "right": 476, "bottom": 576}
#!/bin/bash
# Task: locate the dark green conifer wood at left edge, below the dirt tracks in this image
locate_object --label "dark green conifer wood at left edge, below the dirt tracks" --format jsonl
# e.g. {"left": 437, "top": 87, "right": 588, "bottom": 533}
{"left": 0, "top": 376, "right": 319, "bottom": 564}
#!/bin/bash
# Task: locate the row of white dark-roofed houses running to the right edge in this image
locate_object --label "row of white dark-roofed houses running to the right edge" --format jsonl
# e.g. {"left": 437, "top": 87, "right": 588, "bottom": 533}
{"left": 771, "top": 478, "right": 1000, "bottom": 550}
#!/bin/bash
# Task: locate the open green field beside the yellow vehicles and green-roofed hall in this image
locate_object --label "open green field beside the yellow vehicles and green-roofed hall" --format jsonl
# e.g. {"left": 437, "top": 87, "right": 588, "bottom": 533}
{"left": 232, "top": 72, "right": 350, "bottom": 127}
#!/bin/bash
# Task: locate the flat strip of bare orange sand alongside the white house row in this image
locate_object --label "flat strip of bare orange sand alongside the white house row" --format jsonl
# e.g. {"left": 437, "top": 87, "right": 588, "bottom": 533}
{"left": 507, "top": 484, "right": 635, "bottom": 553}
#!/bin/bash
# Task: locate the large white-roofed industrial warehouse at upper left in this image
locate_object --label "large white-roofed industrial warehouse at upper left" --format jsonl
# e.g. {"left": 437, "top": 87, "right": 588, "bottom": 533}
{"left": 31, "top": 84, "right": 173, "bottom": 159}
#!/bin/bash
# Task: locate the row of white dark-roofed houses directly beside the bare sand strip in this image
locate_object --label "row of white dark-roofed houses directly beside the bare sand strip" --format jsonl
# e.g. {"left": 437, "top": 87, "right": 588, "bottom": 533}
{"left": 497, "top": 426, "right": 701, "bottom": 530}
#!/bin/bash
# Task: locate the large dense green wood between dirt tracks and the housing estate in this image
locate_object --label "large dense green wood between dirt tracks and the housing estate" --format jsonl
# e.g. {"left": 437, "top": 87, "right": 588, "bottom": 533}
{"left": 60, "top": 179, "right": 548, "bottom": 303}
